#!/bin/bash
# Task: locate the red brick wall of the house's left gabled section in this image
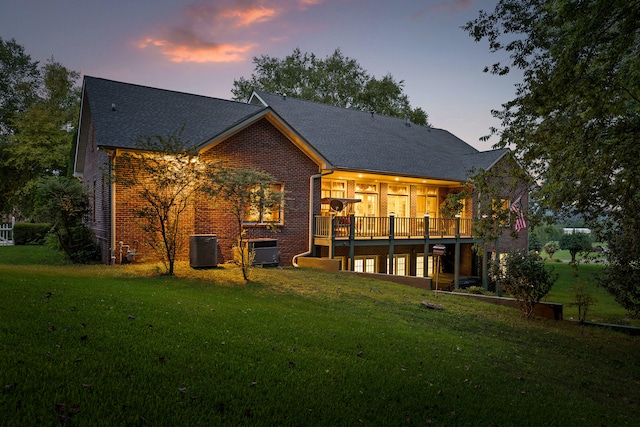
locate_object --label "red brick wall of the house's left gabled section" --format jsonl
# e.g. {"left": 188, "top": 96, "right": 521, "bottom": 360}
{"left": 83, "top": 119, "right": 320, "bottom": 265}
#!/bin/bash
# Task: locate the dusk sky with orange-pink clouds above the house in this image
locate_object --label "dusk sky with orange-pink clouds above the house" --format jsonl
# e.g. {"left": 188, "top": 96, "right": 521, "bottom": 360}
{"left": 0, "top": 0, "right": 517, "bottom": 150}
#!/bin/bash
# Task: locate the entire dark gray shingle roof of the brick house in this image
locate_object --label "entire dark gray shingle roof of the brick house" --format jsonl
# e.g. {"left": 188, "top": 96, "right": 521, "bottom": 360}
{"left": 76, "top": 76, "right": 508, "bottom": 181}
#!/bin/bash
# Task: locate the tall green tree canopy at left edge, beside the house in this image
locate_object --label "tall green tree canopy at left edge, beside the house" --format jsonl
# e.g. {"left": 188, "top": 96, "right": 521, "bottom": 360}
{"left": 0, "top": 39, "right": 80, "bottom": 217}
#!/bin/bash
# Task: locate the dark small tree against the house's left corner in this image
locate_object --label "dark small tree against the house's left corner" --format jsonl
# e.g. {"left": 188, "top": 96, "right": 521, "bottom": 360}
{"left": 35, "top": 177, "right": 100, "bottom": 264}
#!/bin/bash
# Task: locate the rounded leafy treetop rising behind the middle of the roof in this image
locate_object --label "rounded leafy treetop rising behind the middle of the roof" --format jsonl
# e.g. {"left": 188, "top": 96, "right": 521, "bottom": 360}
{"left": 231, "top": 48, "right": 428, "bottom": 125}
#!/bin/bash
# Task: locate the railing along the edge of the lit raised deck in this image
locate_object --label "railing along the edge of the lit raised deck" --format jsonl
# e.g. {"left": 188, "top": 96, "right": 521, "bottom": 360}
{"left": 314, "top": 215, "right": 471, "bottom": 239}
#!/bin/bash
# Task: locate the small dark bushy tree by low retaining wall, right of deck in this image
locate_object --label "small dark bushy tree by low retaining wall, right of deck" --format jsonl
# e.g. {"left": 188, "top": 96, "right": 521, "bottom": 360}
{"left": 497, "top": 250, "right": 558, "bottom": 318}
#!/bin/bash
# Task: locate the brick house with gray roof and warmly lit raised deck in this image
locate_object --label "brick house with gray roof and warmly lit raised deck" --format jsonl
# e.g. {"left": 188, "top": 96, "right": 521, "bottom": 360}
{"left": 75, "top": 76, "right": 528, "bottom": 284}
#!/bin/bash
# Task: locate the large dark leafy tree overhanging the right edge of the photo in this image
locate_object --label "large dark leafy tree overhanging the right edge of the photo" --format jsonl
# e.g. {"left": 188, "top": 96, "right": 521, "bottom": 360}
{"left": 464, "top": 0, "right": 640, "bottom": 318}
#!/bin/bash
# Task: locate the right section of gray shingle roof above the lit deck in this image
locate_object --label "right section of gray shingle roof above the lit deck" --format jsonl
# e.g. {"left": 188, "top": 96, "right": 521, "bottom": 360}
{"left": 253, "top": 92, "right": 508, "bottom": 181}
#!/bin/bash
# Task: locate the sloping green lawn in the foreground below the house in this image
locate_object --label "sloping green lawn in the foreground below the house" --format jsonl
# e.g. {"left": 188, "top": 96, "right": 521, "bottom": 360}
{"left": 0, "top": 247, "right": 640, "bottom": 426}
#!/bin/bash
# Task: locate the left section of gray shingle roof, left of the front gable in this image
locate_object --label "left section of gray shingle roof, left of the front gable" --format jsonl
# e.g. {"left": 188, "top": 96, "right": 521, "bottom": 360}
{"left": 84, "top": 76, "right": 264, "bottom": 148}
